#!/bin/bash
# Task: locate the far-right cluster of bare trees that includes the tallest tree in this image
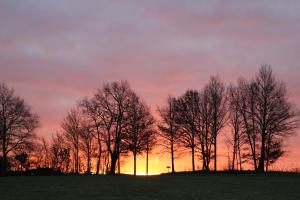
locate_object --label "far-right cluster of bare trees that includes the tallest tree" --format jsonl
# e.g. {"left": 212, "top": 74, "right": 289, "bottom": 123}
{"left": 228, "top": 66, "right": 299, "bottom": 172}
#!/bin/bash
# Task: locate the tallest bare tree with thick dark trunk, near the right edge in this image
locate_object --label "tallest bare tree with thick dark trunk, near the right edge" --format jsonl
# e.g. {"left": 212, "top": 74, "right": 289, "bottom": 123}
{"left": 255, "top": 65, "right": 298, "bottom": 172}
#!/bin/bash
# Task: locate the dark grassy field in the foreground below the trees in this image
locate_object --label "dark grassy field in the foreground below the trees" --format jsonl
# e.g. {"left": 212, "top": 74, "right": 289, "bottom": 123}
{"left": 0, "top": 174, "right": 300, "bottom": 200}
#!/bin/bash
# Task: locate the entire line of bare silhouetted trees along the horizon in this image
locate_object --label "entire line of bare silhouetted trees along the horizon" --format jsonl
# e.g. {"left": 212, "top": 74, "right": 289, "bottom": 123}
{"left": 0, "top": 65, "right": 299, "bottom": 175}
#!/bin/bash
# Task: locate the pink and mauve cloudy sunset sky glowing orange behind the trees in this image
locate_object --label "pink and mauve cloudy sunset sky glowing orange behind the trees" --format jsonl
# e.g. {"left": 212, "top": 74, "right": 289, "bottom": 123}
{"left": 0, "top": 0, "right": 300, "bottom": 173}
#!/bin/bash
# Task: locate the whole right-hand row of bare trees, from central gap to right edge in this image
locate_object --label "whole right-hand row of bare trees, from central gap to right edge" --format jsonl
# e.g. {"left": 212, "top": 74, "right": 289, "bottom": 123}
{"left": 158, "top": 65, "right": 299, "bottom": 172}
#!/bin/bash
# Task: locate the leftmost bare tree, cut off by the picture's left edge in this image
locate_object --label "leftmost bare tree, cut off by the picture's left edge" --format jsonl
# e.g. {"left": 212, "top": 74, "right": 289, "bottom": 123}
{"left": 0, "top": 84, "right": 39, "bottom": 174}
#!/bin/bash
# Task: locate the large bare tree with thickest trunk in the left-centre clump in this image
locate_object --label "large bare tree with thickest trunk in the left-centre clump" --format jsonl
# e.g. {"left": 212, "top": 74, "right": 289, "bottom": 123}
{"left": 95, "top": 81, "right": 132, "bottom": 174}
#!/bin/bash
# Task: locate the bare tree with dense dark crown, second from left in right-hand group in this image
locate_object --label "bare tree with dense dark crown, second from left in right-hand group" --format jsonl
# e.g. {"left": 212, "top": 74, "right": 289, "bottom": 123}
{"left": 176, "top": 90, "right": 200, "bottom": 172}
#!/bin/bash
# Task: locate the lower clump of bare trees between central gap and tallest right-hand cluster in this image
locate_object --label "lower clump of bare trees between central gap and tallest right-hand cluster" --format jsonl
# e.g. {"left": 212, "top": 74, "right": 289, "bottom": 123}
{"left": 158, "top": 77, "right": 227, "bottom": 173}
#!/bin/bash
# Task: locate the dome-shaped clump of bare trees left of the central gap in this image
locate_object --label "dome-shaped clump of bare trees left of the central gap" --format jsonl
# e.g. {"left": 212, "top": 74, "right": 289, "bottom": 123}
{"left": 39, "top": 81, "right": 156, "bottom": 174}
